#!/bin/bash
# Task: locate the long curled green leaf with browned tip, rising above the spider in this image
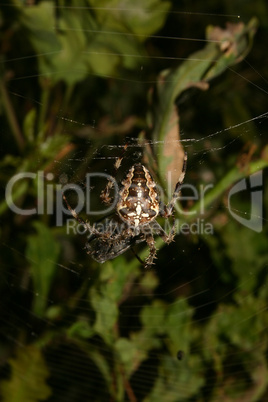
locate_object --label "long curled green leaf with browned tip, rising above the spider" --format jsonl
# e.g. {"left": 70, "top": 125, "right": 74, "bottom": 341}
{"left": 153, "top": 19, "right": 257, "bottom": 181}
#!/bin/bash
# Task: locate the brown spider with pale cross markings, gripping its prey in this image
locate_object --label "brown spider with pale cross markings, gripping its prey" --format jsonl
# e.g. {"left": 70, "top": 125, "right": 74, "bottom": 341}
{"left": 63, "top": 146, "right": 187, "bottom": 268}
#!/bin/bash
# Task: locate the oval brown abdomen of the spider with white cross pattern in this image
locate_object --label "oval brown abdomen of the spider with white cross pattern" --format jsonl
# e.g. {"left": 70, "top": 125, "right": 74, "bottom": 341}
{"left": 117, "top": 164, "right": 159, "bottom": 227}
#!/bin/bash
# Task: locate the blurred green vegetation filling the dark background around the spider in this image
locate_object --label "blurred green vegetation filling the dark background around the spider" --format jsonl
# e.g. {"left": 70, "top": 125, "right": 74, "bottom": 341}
{"left": 0, "top": 0, "right": 268, "bottom": 402}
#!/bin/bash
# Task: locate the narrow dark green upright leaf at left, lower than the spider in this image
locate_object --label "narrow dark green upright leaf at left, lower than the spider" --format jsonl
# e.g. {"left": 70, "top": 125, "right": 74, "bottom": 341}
{"left": 26, "top": 222, "right": 60, "bottom": 317}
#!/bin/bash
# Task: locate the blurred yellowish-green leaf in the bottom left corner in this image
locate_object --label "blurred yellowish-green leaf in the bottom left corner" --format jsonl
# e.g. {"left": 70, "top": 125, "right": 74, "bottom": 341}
{"left": 0, "top": 346, "right": 52, "bottom": 402}
